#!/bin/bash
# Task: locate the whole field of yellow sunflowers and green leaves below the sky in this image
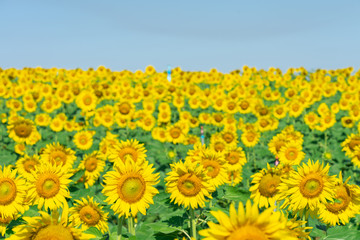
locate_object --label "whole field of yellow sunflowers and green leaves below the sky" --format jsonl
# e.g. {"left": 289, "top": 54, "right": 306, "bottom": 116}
{"left": 0, "top": 66, "right": 360, "bottom": 240}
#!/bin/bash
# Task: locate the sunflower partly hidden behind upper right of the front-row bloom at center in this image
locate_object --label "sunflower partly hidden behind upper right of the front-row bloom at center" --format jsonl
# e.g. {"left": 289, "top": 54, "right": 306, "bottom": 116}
{"left": 194, "top": 148, "right": 228, "bottom": 188}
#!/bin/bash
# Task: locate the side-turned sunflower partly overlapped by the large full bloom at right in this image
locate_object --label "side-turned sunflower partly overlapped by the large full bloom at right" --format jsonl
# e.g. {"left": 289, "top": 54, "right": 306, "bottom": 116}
{"left": 249, "top": 164, "right": 281, "bottom": 208}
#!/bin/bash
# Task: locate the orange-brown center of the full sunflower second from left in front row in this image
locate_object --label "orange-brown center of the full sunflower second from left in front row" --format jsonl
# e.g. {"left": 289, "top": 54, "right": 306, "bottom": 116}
{"left": 36, "top": 173, "right": 60, "bottom": 198}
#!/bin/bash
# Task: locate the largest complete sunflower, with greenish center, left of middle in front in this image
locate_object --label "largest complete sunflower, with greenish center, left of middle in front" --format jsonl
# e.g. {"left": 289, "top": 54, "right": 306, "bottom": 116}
{"left": 102, "top": 159, "right": 159, "bottom": 217}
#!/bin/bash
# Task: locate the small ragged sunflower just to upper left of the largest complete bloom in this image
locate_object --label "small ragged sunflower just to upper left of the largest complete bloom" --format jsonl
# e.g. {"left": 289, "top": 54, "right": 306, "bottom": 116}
{"left": 78, "top": 151, "right": 105, "bottom": 188}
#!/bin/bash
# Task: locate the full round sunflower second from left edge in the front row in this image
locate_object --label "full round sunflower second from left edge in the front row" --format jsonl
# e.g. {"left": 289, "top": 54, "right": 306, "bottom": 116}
{"left": 28, "top": 164, "right": 72, "bottom": 210}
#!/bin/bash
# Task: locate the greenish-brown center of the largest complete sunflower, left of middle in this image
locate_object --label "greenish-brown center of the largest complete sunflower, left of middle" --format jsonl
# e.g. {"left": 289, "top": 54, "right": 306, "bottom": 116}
{"left": 117, "top": 174, "right": 146, "bottom": 203}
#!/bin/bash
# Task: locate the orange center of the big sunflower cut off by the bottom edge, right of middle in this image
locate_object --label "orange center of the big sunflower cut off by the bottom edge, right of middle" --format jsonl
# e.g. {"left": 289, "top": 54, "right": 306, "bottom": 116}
{"left": 226, "top": 225, "right": 268, "bottom": 240}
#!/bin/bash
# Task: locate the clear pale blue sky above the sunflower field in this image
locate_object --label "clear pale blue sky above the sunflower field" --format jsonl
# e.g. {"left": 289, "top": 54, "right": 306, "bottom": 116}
{"left": 0, "top": 0, "right": 360, "bottom": 72}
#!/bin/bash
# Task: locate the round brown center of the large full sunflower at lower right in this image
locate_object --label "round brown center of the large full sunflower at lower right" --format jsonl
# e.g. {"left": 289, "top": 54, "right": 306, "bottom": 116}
{"left": 300, "top": 174, "right": 324, "bottom": 198}
